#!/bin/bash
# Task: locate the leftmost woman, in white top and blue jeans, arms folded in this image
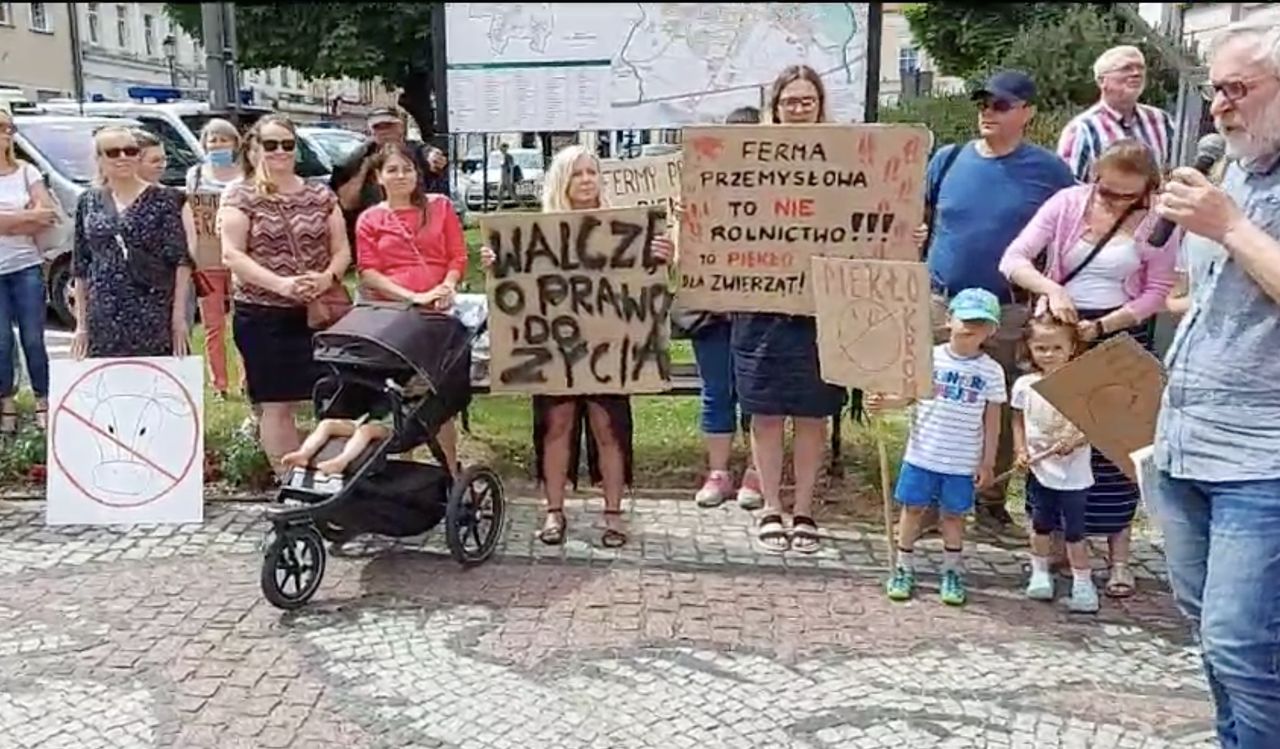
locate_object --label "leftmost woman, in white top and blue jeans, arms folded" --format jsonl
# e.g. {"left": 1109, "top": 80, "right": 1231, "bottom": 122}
{"left": 0, "top": 109, "right": 58, "bottom": 437}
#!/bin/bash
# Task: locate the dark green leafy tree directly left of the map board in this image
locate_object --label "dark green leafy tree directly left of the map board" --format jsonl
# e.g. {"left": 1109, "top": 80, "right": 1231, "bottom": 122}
{"left": 165, "top": 3, "right": 438, "bottom": 137}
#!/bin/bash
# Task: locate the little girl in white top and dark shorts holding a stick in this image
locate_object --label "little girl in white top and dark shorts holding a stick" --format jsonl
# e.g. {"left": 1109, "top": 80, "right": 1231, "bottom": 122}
{"left": 1010, "top": 314, "right": 1098, "bottom": 613}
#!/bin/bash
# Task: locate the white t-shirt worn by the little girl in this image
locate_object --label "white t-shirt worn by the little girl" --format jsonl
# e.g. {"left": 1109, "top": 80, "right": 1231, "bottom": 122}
{"left": 1009, "top": 373, "right": 1093, "bottom": 492}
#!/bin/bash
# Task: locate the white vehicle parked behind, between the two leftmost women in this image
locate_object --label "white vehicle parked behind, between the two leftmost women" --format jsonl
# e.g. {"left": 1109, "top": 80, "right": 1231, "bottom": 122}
{"left": 13, "top": 114, "right": 146, "bottom": 326}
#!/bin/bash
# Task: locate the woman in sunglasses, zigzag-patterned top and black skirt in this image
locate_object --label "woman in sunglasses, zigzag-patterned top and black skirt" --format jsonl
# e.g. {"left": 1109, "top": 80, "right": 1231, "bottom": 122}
{"left": 218, "top": 115, "right": 351, "bottom": 472}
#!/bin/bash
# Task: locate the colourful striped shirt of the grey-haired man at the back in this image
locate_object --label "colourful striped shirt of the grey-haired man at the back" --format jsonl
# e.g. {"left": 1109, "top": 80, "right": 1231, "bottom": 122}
{"left": 1057, "top": 101, "right": 1174, "bottom": 182}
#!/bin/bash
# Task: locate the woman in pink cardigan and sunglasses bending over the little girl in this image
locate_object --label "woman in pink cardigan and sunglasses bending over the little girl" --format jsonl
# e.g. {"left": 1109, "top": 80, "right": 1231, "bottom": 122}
{"left": 1000, "top": 140, "right": 1178, "bottom": 598}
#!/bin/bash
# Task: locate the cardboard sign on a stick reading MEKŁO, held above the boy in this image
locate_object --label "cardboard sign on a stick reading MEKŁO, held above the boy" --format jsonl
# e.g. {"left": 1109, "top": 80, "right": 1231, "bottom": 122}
{"left": 812, "top": 257, "right": 933, "bottom": 398}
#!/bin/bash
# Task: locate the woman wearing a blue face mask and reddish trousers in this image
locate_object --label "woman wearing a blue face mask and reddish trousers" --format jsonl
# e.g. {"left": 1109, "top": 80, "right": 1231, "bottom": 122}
{"left": 187, "top": 118, "right": 244, "bottom": 396}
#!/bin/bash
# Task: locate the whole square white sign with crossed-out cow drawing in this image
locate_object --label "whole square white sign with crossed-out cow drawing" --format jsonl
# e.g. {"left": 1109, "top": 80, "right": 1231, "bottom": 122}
{"left": 45, "top": 356, "right": 205, "bottom": 525}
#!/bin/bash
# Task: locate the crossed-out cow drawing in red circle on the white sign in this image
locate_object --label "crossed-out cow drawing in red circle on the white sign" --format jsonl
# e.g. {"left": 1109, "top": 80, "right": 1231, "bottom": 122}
{"left": 73, "top": 371, "right": 197, "bottom": 501}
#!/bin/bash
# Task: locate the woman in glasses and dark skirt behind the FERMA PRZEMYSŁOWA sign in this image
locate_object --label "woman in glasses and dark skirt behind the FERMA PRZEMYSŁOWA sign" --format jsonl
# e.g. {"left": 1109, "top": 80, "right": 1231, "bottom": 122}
{"left": 731, "top": 65, "right": 845, "bottom": 553}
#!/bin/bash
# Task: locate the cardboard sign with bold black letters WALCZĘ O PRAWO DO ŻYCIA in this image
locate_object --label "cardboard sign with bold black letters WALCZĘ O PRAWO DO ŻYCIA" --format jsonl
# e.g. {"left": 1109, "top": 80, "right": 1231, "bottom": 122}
{"left": 480, "top": 206, "right": 675, "bottom": 396}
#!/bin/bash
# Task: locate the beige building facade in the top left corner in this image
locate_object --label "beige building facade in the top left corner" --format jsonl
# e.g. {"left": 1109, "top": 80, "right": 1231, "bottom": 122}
{"left": 0, "top": 3, "right": 76, "bottom": 101}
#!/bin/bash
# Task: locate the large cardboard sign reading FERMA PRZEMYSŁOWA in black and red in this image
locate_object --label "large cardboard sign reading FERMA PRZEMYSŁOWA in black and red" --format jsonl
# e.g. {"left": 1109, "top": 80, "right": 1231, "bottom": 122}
{"left": 680, "top": 124, "right": 929, "bottom": 315}
